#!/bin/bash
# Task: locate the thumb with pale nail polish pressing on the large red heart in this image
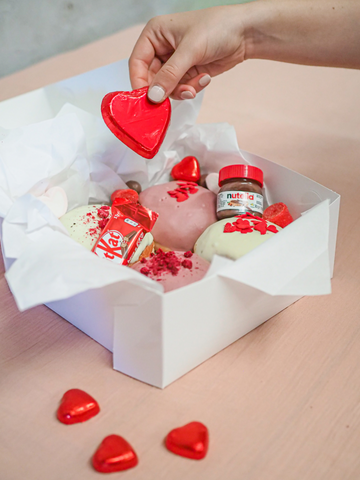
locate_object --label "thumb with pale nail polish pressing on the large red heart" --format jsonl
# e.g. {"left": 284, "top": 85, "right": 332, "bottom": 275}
{"left": 148, "top": 44, "right": 194, "bottom": 103}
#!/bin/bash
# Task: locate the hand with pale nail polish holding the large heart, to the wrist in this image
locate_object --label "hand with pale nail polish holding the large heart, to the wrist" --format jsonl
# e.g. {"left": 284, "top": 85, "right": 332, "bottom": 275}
{"left": 129, "top": 5, "right": 245, "bottom": 103}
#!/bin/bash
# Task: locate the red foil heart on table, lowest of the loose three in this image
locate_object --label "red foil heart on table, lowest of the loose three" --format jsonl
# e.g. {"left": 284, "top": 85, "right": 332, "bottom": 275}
{"left": 92, "top": 435, "right": 138, "bottom": 473}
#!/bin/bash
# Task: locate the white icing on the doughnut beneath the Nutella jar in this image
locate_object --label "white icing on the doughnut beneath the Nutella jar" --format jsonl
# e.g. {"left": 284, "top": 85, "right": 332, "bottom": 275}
{"left": 194, "top": 217, "right": 281, "bottom": 262}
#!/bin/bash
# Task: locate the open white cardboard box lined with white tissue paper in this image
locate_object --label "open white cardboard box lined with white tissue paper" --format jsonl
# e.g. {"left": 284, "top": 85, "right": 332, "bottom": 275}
{"left": 0, "top": 61, "right": 340, "bottom": 388}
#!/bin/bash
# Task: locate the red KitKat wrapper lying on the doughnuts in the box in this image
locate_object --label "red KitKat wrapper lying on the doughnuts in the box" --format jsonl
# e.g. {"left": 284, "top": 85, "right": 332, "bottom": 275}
{"left": 92, "top": 198, "right": 159, "bottom": 265}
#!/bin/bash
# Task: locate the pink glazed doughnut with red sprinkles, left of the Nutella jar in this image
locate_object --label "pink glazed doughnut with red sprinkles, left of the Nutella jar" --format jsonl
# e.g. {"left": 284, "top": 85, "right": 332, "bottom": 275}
{"left": 139, "top": 181, "right": 217, "bottom": 251}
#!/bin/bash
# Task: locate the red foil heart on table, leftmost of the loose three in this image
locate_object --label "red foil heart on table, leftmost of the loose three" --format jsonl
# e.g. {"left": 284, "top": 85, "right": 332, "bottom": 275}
{"left": 57, "top": 388, "right": 100, "bottom": 425}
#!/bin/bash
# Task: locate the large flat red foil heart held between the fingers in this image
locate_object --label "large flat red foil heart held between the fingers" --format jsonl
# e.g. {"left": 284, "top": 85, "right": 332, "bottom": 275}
{"left": 101, "top": 87, "right": 171, "bottom": 158}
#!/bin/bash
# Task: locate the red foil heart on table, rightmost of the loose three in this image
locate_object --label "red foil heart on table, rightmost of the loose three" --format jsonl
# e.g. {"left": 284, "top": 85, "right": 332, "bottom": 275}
{"left": 165, "top": 422, "right": 209, "bottom": 460}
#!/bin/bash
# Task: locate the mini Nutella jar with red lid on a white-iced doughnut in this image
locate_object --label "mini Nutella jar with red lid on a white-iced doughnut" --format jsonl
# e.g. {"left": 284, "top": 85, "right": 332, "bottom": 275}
{"left": 216, "top": 165, "right": 264, "bottom": 220}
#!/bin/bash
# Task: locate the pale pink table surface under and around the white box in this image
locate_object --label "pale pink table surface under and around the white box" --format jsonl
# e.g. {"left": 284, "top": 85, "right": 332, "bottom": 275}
{"left": 0, "top": 26, "right": 360, "bottom": 480}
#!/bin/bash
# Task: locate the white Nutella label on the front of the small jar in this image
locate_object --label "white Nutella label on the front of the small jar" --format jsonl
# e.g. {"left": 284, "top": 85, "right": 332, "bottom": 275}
{"left": 217, "top": 190, "right": 263, "bottom": 214}
